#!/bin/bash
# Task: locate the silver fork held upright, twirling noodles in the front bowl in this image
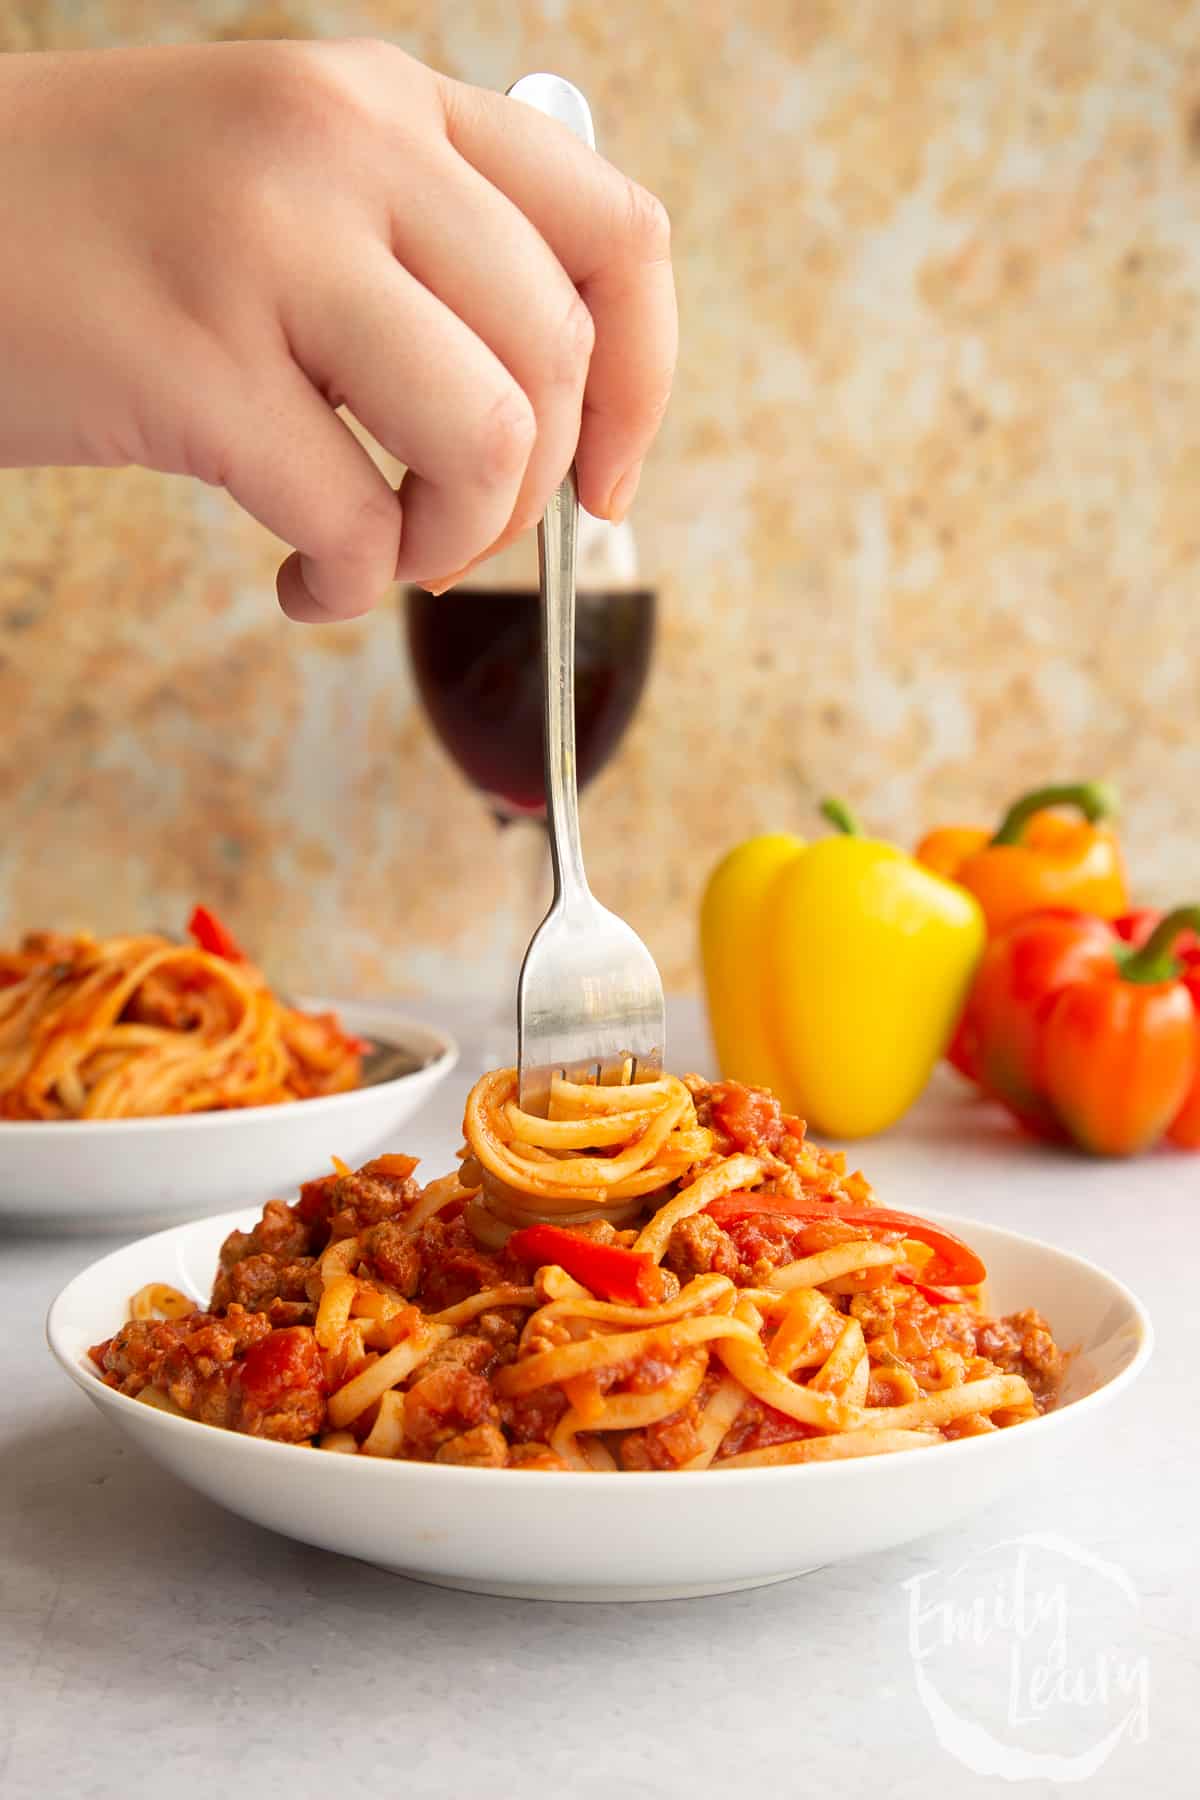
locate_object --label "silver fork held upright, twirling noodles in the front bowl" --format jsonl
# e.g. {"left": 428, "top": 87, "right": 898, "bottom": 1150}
{"left": 509, "top": 76, "right": 666, "bottom": 1118}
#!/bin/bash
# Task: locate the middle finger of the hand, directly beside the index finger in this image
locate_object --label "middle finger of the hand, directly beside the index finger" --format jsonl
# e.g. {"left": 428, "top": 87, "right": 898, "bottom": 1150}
{"left": 394, "top": 149, "right": 596, "bottom": 576}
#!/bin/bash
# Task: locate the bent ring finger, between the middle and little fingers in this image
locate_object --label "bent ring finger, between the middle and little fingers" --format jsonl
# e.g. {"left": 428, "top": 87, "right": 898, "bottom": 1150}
{"left": 286, "top": 238, "right": 536, "bottom": 583}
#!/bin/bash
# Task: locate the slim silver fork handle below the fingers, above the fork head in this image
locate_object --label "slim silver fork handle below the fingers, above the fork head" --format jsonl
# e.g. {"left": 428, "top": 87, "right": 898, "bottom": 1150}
{"left": 538, "top": 468, "right": 588, "bottom": 911}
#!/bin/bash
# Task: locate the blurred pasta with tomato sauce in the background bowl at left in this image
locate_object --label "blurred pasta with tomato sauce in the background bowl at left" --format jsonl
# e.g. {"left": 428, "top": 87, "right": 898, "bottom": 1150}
{"left": 0, "top": 907, "right": 362, "bottom": 1120}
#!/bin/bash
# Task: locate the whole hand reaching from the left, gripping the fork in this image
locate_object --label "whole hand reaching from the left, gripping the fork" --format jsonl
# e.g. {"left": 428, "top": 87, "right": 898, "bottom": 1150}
{"left": 0, "top": 41, "right": 676, "bottom": 619}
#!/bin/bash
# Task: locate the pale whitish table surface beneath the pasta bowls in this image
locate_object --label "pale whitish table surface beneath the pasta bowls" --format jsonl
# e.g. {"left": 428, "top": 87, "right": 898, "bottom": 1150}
{"left": 0, "top": 1003, "right": 1200, "bottom": 1800}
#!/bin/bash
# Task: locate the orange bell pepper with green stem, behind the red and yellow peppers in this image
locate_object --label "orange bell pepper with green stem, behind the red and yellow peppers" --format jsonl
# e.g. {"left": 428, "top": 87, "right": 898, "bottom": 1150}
{"left": 916, "top": 781, "right": 1128, "bottom": 932}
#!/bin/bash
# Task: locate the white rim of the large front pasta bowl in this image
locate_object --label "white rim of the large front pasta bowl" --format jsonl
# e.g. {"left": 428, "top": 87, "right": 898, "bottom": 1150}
{"left": 45, "top": 1206, "right": 1155, "bottom": 1496}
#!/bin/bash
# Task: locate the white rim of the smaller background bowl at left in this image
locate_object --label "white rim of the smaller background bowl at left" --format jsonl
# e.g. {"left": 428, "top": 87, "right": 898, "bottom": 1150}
{"left": 0, "top": 995, "right": 461, "bottom": 1137}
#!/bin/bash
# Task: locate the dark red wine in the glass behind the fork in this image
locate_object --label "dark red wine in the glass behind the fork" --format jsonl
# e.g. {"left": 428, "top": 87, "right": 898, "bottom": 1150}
{"left": 407, "top": 587, "right": 655, "bottom": 817}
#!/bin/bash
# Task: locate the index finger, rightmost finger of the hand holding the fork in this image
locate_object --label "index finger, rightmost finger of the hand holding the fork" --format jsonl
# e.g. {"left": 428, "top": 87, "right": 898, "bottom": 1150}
{"left": 443, "top": 81, "right": 678, "bottom": 518}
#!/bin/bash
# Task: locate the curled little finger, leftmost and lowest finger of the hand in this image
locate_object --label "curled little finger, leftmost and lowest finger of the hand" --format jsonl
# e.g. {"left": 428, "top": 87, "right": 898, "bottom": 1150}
{"left": 219, "top": 362, "right": 413, "bottom": 625}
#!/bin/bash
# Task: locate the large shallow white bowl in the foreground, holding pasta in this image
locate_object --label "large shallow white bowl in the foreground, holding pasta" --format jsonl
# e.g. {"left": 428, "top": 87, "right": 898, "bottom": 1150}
{"left": 47, "top": 1213, "right": 1151, "bottom": 1600}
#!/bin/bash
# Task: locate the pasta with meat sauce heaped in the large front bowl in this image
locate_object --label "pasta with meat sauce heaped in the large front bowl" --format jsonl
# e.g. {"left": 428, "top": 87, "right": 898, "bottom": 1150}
{"left": 92, "top": 1071, "right": 1061, "bottom": 1471}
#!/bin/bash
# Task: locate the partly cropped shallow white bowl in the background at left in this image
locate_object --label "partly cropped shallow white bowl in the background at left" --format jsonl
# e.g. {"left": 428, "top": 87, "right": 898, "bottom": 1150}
{"left": 0, "top": 1001, "right": 459, "bottom": 1231}
